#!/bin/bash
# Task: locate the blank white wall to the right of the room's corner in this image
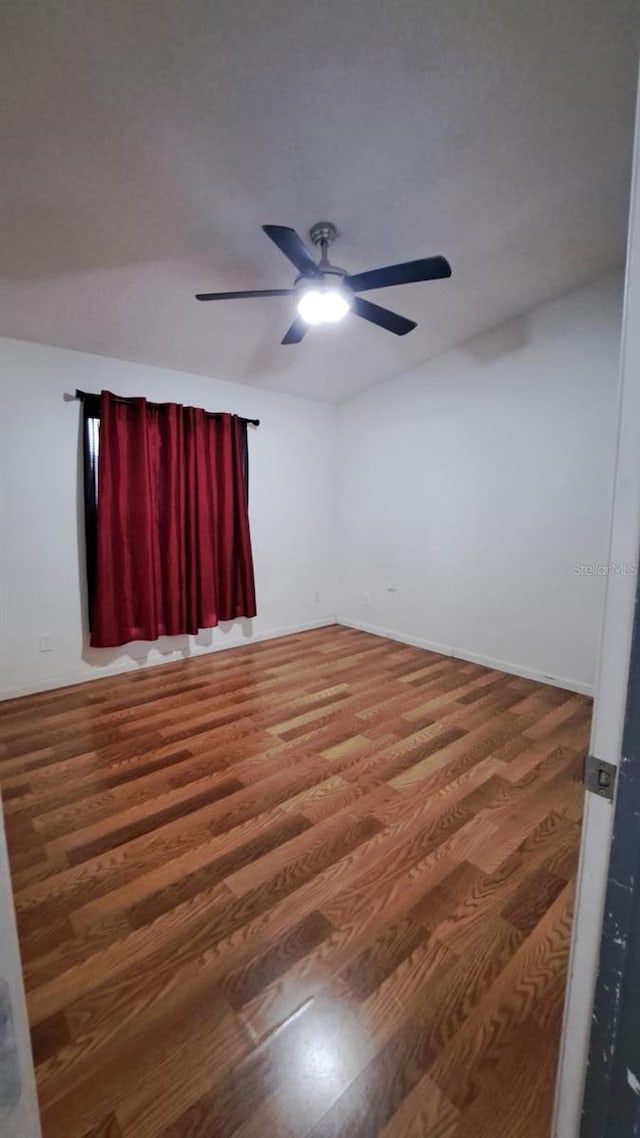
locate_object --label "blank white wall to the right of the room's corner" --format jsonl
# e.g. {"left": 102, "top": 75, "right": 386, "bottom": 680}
{"left": 338, "top": 279, "right": 622, "bottom": 692}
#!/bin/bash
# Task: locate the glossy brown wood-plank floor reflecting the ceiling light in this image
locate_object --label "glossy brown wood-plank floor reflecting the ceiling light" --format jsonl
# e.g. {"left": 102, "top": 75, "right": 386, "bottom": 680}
{"left": 0, "top": 627, "right": 591, "bottom": 1138}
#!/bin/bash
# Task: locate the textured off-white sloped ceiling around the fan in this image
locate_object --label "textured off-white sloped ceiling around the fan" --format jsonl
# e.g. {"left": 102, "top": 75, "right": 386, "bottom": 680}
{"left": 0, "top": 0, "right": 639, "bottom": 399}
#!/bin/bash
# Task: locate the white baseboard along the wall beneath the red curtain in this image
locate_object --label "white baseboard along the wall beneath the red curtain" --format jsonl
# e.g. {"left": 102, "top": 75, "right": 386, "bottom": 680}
{"left": 0, "top": 616, "right": 337, "bottom": 701}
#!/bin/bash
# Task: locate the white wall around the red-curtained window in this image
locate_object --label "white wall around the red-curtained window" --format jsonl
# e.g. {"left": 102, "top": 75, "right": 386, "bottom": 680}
{"left": 0, "top": 339, "right": 336, "bottom": 696}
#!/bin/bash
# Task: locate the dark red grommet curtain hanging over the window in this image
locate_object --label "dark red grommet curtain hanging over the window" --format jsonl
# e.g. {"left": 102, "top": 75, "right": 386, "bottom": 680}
{"left": 91, "top": 391, "right": 256, "bottom": 648}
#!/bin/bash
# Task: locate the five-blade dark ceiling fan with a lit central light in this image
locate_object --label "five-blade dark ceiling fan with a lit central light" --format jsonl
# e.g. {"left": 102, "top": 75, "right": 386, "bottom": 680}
{"left": 196, "top": 221, "right": 451, "bottom": 344}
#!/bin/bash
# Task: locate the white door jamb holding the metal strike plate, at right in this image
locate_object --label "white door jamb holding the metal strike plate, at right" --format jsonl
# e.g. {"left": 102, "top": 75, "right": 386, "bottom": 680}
{"left": 552, "top": 60, "right": 640, "bottom": 1138}
